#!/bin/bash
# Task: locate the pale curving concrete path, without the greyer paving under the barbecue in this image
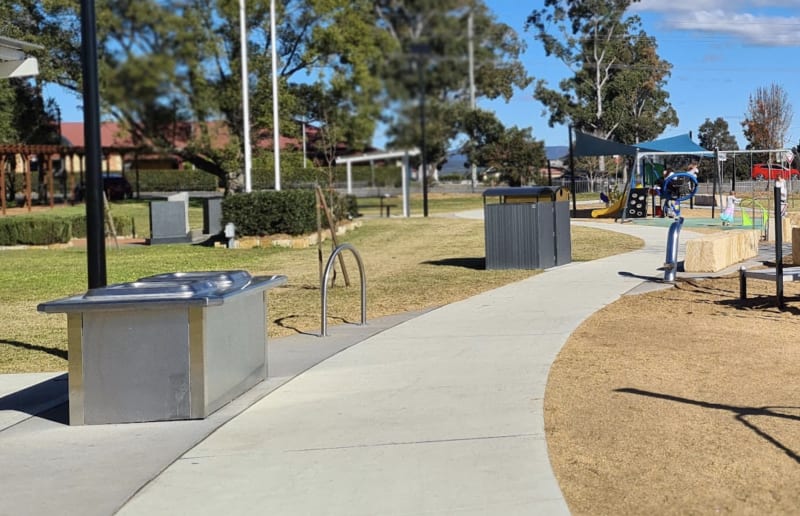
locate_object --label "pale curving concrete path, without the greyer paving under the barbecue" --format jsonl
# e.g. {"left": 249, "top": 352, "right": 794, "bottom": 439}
{"left": 121, "top": 224, "right": 680, "bottom": 516}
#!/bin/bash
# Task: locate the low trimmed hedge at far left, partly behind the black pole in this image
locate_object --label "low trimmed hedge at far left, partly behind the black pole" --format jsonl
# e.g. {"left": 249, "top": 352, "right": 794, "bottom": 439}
{"left": 0, "top": 215, "right": 136, "bottom": 246}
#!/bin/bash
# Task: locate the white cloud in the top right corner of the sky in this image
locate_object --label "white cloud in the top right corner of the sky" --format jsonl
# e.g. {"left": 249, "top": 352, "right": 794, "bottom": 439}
{"left": 631, "top": 0, "right": 800, "bottom": 47}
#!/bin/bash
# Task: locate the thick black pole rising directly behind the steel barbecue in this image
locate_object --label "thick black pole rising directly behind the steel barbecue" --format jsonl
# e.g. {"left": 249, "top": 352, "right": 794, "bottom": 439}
{"left": 81, "top": 0, "right": 107, "bottom": 289}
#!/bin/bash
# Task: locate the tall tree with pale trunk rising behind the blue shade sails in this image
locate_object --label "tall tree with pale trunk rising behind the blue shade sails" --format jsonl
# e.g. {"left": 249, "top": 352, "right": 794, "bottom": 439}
{"left": 526, "top": 0, "right": 678, "bottom": 149}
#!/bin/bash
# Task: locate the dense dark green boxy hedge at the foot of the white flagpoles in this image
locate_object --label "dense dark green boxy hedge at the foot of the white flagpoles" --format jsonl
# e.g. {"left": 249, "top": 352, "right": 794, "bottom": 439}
{"left": 222, "top": 190, "right": 357, "bottom": 236}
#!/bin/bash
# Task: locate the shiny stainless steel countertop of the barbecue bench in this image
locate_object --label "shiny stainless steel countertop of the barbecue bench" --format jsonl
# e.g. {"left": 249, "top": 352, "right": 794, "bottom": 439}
{"left": 37, "top": 271, "right": 286, "bottom": 313}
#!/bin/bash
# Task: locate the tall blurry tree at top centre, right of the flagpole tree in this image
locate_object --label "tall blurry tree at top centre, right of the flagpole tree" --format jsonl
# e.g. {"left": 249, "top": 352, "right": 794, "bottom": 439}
{"left": 375, "top": 0, "right": 530, "bottom": 176}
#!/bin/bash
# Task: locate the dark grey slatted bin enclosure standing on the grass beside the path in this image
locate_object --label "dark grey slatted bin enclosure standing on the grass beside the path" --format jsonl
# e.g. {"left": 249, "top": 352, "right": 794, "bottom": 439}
{"left": 483, "top": 186, "right": 572, "bottom": 270}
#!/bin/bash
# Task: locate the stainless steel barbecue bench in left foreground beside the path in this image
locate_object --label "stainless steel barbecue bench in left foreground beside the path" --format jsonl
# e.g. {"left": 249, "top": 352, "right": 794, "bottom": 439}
{"left": 38, "top": 271, "right": 286, "bottom": 425}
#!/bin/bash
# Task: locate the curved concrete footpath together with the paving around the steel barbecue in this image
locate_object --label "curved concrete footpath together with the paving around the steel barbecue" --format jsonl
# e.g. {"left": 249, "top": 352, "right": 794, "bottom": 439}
{"left": 0, "top": 220, "right": 693, "bottom": 516}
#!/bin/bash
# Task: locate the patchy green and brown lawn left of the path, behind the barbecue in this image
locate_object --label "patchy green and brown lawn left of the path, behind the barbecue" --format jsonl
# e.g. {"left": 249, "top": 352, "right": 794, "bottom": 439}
{"left": 0, "top": 196, "right": 641, "bottom": 373}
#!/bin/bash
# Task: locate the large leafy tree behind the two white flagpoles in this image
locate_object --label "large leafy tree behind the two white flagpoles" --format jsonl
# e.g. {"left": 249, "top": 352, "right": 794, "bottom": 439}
{"left": 97, "top": 0, "right": 394, "bottom": 189}
